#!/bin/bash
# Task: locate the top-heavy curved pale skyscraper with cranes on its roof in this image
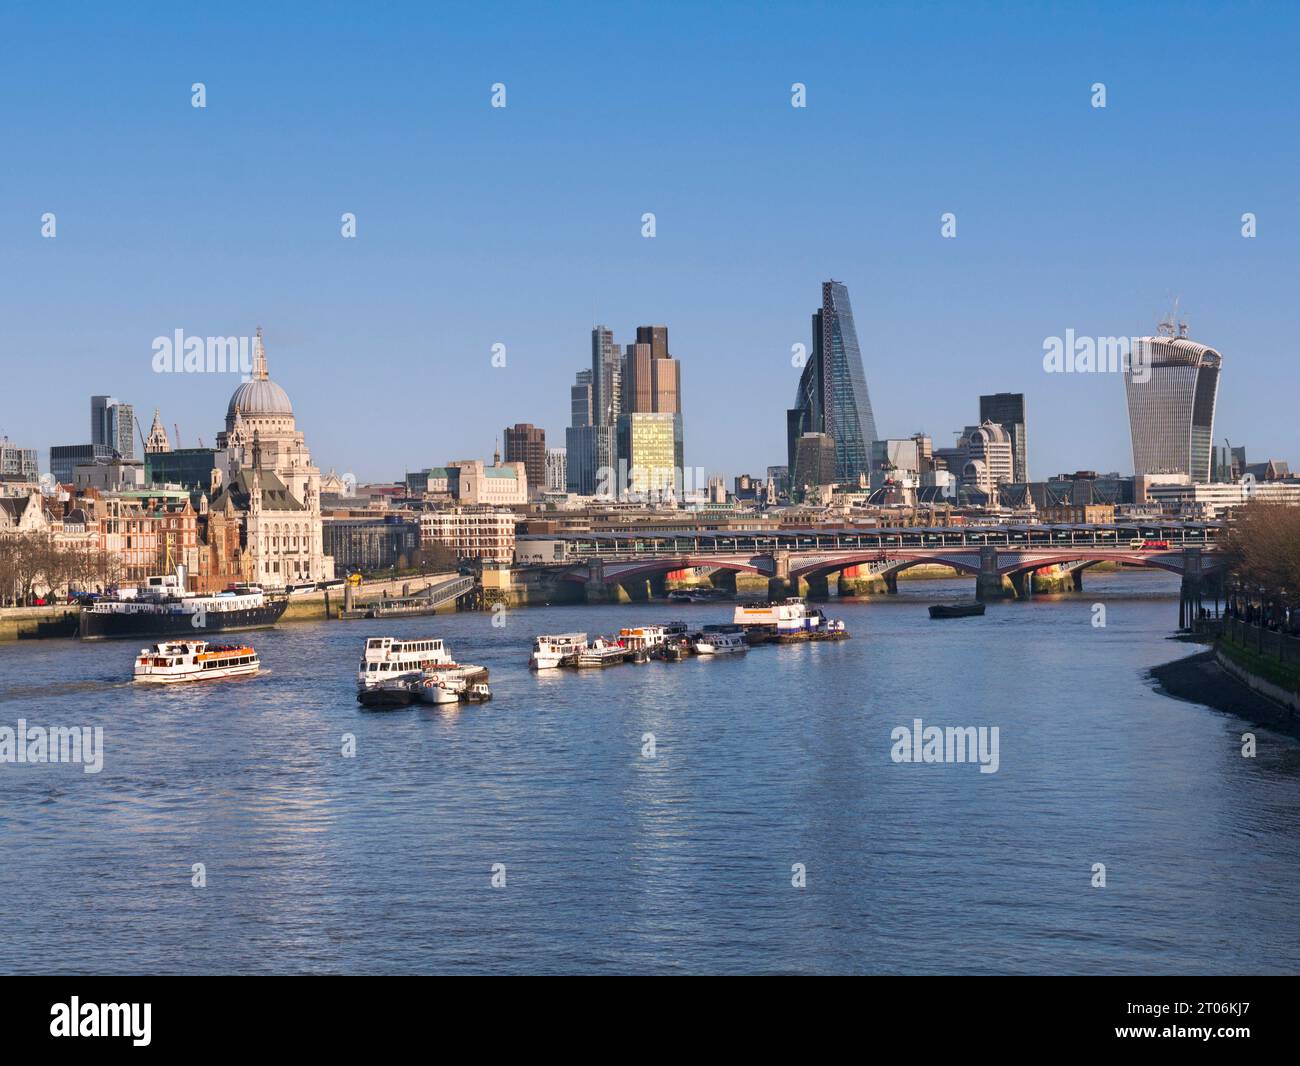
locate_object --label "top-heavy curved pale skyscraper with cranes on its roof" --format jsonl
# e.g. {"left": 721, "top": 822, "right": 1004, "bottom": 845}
{"left": 1125, "top": 324, "right": 1223, "bottom": 482}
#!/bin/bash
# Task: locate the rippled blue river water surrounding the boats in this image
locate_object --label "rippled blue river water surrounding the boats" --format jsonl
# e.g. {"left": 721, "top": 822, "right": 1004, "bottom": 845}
{"left": 0, "top": 575, "right": 1300, "bottom": 972}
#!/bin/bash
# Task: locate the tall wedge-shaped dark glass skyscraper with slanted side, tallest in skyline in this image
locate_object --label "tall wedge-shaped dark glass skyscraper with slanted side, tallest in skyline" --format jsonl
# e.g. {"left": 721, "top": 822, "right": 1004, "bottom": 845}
{"left": 785, "top": 281, "right": 876, "bottom": 490}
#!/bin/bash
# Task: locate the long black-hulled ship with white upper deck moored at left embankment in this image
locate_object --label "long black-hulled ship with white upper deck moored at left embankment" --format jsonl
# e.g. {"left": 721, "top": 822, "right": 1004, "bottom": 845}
{"left": 78, "top": 567, "right": 289, "bottom": 641}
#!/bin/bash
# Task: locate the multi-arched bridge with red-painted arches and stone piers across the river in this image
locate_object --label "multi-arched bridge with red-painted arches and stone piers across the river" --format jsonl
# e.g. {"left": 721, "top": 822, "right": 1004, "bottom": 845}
{"left": 515, "top": 520, "right": 1223, "bottom": 602}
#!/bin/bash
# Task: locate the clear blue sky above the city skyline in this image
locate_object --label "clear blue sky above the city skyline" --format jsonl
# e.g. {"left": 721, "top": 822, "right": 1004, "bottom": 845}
{"left": 0, "top": 3, "right": 1300, "bottom": 481}
